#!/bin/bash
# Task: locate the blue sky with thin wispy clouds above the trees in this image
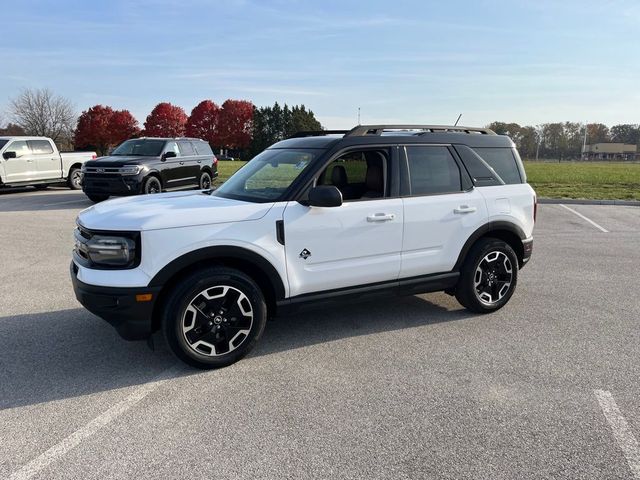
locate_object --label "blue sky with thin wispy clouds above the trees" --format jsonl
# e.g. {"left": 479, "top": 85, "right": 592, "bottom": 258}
{"left": 0, "top": 0, "right": 640, "bottom": 128}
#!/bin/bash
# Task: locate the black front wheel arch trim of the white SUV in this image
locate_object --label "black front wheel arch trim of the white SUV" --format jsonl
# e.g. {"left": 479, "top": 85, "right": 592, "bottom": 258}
{"left": 149, "top": 246, "right": 285, "bottom": 331}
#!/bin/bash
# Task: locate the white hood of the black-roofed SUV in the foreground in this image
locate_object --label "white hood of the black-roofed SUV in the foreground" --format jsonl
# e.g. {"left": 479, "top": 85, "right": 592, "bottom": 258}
{"left": 78, "top": 191, "right": 273, "bottom": 231}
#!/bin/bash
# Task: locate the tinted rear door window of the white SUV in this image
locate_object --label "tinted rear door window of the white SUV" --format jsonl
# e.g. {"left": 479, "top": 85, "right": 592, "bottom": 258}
{"left": 406, "top": 146, "right": 462, "bottom": 195}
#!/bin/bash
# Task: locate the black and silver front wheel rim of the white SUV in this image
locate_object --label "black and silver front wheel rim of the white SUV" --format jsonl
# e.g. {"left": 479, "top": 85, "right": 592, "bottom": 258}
{"left": 180, "top": 285, "right": 253, "bottom": 357}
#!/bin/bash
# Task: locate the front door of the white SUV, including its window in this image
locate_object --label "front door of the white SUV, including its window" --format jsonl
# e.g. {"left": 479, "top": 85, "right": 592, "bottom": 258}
{"left": 284, "top": 150, "right": 403, "bottom": 296}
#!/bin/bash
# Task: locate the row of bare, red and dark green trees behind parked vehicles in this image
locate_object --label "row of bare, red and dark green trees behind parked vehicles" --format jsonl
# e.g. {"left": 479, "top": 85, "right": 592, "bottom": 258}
{"left": 0, "top": 89, "right": 323, "bottom": 158}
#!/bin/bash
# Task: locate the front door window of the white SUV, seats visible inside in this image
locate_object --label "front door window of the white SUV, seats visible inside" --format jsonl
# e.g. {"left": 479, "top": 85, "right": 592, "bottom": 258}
{"left": 317, "top": 150, "right": 388, "bottom": 201}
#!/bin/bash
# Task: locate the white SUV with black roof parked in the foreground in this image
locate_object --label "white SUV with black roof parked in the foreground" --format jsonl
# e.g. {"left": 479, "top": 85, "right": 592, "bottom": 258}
{"left": 71, "top": 125, "right": 536, "bottom": 368}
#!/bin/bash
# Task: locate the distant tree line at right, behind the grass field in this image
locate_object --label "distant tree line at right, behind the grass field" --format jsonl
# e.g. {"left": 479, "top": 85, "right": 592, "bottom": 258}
{"left": 487, "top": 122, "right": 640, "bottom": 160}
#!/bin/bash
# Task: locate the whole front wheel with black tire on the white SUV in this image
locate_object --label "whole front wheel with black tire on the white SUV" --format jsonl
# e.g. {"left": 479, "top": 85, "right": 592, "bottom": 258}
{"left": 162, "top": 267, "right": 267, "bottom": 369}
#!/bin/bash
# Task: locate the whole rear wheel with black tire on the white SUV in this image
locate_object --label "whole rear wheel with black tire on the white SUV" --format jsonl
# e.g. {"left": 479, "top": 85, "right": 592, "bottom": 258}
{"left": 455, "top": 238, "right": 518, "bottom": 313}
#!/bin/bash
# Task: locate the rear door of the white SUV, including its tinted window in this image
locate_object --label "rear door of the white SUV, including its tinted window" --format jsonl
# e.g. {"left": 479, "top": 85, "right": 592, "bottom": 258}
{"left": 400, "top": 145, "right": 487, "bottom": 278}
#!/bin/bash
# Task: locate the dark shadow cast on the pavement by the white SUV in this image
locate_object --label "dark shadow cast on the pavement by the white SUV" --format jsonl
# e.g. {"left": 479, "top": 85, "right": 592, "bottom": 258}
{"left": 0, "top": 297, "right": 472, "bottom": 410}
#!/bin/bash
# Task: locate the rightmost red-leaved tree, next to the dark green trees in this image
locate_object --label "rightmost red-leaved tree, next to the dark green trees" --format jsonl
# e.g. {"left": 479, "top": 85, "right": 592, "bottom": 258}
{"left": 215, "top": 100, "right": 253, "bottom": 149}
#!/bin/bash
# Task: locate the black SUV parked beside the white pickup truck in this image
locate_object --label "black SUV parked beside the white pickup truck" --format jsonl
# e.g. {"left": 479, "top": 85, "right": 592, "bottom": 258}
{"left": 82, "top": 138, "right": 218, "bottom": 202}
